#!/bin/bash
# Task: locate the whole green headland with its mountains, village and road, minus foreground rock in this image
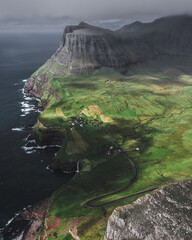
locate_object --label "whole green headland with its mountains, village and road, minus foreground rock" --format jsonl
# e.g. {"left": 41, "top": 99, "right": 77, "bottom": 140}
{"left": 16, "top": 16, "right": 192, "bottom": 240}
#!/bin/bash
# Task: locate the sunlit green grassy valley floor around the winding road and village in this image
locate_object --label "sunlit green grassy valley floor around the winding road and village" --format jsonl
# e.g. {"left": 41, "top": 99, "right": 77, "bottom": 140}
{"left": 33, "top": 59, "right": 192, "bottom": 240}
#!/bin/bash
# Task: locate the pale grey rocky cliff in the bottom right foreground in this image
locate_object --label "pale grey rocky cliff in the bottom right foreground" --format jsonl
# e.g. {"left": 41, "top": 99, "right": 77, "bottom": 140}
{"left": 105, "top": 181, "right": 192, "bottom": 240}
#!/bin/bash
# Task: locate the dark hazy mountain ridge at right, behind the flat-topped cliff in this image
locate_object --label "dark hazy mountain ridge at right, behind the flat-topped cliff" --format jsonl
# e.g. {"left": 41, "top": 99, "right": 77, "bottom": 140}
{"left": 117, "top": 15, "right": 192, "bottom": 57}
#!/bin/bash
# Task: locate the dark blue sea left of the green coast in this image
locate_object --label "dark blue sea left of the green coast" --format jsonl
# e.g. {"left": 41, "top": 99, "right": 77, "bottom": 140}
{"left": 0, "top": 33, "right": 69, "bottom": 234}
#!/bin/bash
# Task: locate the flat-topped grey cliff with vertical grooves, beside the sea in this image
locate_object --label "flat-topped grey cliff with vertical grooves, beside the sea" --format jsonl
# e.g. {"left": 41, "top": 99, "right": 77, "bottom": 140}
{"left": 51, "top": 23, "right": 135, "bottom": 70}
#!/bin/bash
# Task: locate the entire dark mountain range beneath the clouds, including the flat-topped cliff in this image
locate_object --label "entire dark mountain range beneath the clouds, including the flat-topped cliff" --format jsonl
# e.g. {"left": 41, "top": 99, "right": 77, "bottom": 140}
{"left": 39, "top": 16, "right": 192, "bottom": 73}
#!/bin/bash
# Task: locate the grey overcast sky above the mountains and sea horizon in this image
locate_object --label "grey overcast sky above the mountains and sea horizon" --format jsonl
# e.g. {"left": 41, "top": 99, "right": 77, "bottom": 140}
{"left": 0, "top": 0, "right": 192, "bottom": 31}
